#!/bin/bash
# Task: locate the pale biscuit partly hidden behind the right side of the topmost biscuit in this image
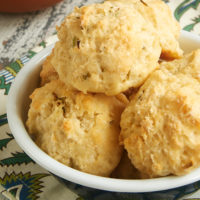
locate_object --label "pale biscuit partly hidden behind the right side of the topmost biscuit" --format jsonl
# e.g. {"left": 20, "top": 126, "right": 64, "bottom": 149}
{"left": 109, "top": 0, "right": 183, "bottom": 60}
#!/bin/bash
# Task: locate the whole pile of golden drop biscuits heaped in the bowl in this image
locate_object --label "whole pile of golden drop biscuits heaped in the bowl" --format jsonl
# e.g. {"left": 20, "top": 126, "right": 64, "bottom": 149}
{"left": 26, "top": 0, "right": 200, "bottom": 179}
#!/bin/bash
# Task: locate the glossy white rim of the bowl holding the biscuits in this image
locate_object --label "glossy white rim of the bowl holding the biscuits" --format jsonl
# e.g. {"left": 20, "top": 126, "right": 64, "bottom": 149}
{"left": 7, "top": 31, "right": 200, "bottom": 193}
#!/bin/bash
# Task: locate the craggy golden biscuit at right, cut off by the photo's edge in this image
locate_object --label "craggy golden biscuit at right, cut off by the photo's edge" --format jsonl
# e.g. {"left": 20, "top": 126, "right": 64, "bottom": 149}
{"left": 120, "top": 50, "right": 200, "bottom": 177}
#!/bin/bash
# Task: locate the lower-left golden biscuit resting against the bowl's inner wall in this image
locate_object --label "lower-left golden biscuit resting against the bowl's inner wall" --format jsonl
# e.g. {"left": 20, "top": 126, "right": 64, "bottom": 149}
{"left": 26, "top": 80, "right": 124, "bottom": 176}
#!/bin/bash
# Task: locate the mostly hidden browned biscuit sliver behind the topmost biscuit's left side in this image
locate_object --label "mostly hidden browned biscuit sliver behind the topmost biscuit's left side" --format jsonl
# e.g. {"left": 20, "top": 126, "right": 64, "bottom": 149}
{"left": 40, "top": 50, "right": 58, "bottom": 86}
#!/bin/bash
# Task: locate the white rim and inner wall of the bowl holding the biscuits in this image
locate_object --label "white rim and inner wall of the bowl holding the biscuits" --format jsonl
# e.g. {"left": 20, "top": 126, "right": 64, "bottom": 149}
{"left": 7, "top": 31, "right": 200, "bottom": 198}
